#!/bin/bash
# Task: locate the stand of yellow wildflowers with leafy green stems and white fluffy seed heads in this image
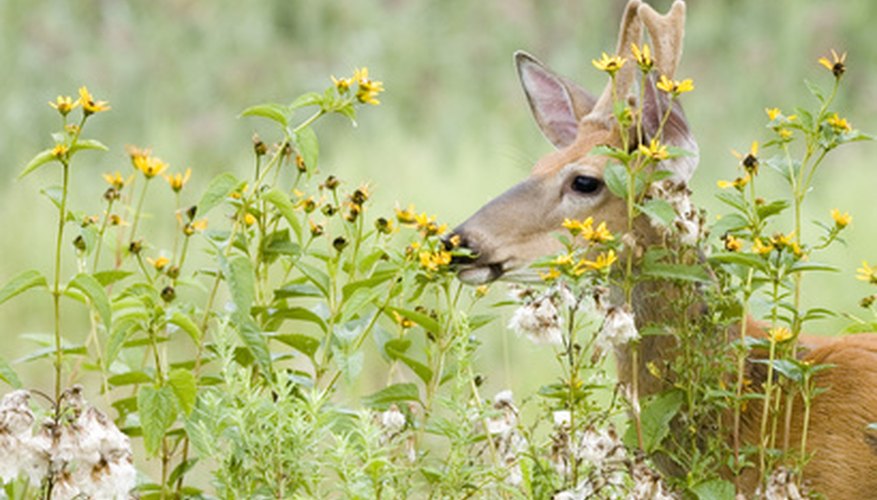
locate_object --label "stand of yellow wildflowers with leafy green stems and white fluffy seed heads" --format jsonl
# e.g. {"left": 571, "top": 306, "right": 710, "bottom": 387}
{"left": 0, "top": 45, "right": 877, "bottom": 499}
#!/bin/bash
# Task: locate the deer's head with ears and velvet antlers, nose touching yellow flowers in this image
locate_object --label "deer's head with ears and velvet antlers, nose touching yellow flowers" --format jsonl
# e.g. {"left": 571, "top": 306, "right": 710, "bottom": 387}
{"left": 452, "top": 0, "right": 697, "bottom": 283}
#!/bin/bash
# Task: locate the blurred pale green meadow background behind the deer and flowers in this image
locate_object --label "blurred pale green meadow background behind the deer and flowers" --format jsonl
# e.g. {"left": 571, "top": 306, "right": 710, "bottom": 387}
{"left": 0, "top": 0, "right": 877, "bottom": 454}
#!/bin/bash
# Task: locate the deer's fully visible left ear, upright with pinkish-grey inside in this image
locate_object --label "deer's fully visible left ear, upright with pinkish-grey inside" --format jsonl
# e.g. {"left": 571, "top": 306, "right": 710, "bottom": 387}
{"left": 515, "top": 51, "right": 597, "bottom": 148}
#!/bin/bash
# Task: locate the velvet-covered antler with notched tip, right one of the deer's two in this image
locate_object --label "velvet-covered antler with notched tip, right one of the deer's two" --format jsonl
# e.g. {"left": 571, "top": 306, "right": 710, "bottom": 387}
{"left": 637, "top": 0, "right": 685, "bottom": 78}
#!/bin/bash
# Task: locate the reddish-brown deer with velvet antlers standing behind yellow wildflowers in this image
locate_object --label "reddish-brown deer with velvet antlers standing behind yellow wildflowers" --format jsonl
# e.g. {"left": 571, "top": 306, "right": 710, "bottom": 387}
{"left": 450, "top": 0, "right": 877, "bottom": 499}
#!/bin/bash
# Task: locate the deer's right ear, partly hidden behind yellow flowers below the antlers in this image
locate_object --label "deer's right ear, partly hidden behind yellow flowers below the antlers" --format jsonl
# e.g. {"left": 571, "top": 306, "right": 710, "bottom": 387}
{"left": 643, "top": 73, "right": 700, "bottom": 183}
